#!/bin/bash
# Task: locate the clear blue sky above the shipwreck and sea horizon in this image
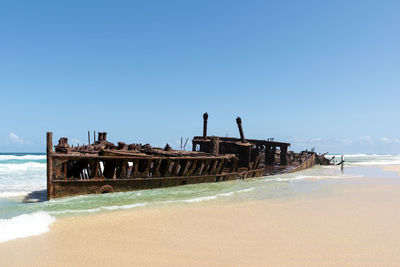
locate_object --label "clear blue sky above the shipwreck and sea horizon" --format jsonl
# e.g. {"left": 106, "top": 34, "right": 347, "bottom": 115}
{"left": 0, "top": 0, "right": 400, "bottom": 154}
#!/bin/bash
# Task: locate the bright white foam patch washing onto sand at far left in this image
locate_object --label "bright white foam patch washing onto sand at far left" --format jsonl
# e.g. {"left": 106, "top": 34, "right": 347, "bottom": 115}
{"left": 0, "top": 211, "right": 56, "bottom": 243}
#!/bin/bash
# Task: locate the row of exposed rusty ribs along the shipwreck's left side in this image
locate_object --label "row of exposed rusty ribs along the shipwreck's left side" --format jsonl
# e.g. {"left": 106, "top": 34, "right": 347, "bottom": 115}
{"left": 53, "top": 155, "right": 237, "bottom": 180}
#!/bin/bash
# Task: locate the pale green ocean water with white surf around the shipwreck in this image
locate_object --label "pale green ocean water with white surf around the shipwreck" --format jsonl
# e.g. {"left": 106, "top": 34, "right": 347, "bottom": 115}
{"left": 0, "top": 154, "right": 400, "bottom": 242}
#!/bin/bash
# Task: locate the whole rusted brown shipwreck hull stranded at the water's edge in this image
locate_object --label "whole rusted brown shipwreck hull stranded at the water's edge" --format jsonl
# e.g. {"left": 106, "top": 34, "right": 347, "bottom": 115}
{"left": 47, "top": 113, "right": 328, "bottom": 199}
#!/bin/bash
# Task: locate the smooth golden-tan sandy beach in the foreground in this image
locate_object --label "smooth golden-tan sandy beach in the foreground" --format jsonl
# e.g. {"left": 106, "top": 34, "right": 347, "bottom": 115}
{"left": 0, "top": 167, "right": 400, "bottom": 266}
